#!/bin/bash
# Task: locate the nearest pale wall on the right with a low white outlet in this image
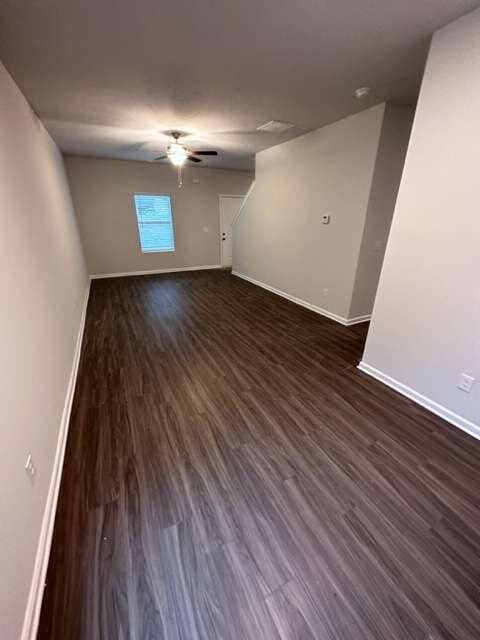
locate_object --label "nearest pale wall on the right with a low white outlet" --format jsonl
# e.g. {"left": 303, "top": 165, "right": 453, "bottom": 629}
{"left": 363, "top": 11, "right": 480, "bottom": 435}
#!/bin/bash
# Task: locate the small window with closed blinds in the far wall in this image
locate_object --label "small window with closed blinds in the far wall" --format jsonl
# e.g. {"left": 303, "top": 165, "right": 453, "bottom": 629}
{"left": 135, "top": 193, "right": 175, "bottom": 253}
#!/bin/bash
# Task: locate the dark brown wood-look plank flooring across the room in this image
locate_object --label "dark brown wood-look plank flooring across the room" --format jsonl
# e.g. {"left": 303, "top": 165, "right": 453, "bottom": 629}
{"left": 39, "top": 272, "right": 480, "bottom": 640}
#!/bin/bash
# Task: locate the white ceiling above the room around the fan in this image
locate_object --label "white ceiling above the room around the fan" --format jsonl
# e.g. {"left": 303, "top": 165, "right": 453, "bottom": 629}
{"left": 0, "top": 0, "right": 479, "bottom": 169}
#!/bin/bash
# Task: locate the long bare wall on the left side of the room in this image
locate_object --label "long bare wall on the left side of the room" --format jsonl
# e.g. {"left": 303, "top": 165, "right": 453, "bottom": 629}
{"left": 0, "top": 64, "right": 87, "bottom": 640}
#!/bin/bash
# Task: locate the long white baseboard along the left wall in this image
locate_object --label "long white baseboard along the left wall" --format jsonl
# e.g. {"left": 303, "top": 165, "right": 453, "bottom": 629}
{"left": 21, "top": 281, "right": 90, "bottom": 640}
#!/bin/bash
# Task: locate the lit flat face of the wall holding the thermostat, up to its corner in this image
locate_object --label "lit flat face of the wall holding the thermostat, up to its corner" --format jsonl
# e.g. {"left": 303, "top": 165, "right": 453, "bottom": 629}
{"left": 233, "top": 104, "right": 385, "bottom": 317}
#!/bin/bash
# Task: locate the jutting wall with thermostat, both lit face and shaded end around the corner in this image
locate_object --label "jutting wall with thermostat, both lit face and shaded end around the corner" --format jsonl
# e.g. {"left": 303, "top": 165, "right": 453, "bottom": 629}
{"left": 233, "top": 104, "right": 411, "bottom": 321}
